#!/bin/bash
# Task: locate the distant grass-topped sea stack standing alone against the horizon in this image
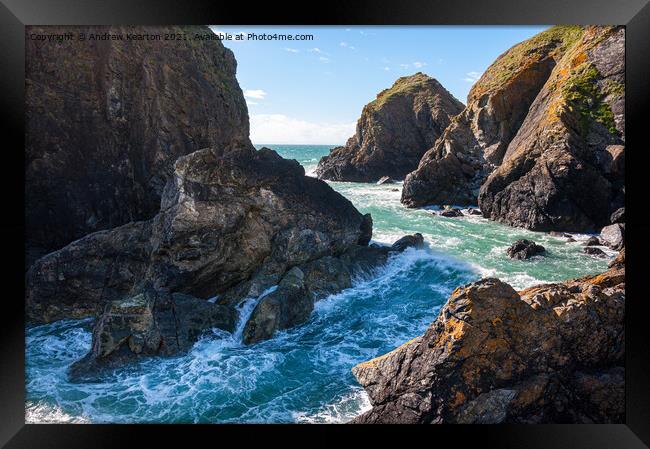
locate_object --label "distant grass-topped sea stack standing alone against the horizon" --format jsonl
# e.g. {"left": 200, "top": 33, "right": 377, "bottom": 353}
{"left": 316, "top": 73, "right": 463, "bottom": 182}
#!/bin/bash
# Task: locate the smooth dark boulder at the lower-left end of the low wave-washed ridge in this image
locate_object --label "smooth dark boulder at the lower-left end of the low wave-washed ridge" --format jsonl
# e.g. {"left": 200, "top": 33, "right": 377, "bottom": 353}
{"left": 243, "top": 267, "right": 314, "bottom": 344}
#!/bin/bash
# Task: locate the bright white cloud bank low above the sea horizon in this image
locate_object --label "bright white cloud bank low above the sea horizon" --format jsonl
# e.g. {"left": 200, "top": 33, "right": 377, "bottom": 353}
{"left": 250, "top": 114, "right": 356, "bottom": 145}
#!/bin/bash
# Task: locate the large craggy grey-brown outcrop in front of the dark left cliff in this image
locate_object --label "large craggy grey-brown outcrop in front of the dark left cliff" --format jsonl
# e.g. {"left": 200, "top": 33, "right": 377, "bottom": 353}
{"left": 26, "top": 147, "right": 372, "bottom": 322}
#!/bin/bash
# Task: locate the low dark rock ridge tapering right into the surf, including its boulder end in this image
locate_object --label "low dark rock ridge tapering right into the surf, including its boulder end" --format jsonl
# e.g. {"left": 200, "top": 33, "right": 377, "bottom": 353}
{"left": 242, "top": 233, "right": 424, "bottom": 344}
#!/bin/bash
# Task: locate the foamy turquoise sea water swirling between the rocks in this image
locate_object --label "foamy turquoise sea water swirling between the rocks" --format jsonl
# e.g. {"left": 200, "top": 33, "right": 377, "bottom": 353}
{"left": 26, "top": 145, "right": 614, "bottom": 423}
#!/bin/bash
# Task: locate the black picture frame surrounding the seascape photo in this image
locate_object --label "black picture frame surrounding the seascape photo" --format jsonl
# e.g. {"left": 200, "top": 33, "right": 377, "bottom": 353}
{"left": 0, "top": 0, "right": 650, "bottom": 449}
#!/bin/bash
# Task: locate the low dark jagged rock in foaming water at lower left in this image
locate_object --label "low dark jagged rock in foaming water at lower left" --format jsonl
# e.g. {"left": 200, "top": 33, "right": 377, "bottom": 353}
{"left": 70, "top": 289, "right": 237, "bottom": 379}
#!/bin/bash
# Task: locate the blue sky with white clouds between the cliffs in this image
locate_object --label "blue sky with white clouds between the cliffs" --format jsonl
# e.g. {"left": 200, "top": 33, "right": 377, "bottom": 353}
{"left": 212, "top": 25, "right": 548, "bottom": 145}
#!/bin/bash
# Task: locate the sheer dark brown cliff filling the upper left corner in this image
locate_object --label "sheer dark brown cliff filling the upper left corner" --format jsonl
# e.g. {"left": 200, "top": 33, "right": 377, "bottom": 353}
{"left": 25, "top": 26, "right": 250, "bottom": 264}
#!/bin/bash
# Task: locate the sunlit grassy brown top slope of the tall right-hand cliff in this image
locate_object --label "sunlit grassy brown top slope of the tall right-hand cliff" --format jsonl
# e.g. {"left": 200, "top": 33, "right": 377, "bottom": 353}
{"left": 469, "top": 25, "right": 584, "bottom": 98}
